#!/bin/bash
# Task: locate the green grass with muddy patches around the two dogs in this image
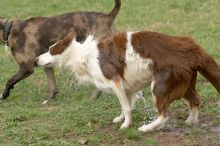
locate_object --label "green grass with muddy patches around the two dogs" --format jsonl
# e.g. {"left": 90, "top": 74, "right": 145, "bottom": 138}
{"left": 0, "top": 0, "right": 220, "bottom": 146}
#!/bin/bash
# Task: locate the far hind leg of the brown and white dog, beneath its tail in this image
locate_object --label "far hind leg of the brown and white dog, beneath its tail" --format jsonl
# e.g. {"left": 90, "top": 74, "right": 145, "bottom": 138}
{"left": 184, "top": 72, "right": 200, "bottom": 125}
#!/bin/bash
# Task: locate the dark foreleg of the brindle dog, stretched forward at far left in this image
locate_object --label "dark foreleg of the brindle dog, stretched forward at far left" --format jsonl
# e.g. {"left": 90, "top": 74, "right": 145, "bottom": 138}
{"left": 1, "top": 64, "right": 34, "bottom": 99}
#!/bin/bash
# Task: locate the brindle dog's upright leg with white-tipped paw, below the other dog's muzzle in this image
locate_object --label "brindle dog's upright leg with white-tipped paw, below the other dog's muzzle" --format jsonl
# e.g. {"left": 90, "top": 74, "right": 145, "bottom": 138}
{"left": 42, "top": 67, "right": 58, "bottom": 104}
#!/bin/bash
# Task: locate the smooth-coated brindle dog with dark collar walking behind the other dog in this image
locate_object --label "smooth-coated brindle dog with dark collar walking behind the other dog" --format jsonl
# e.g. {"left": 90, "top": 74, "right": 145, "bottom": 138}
{"left": 0, "top": 0, "right": 121, "bottom": 103}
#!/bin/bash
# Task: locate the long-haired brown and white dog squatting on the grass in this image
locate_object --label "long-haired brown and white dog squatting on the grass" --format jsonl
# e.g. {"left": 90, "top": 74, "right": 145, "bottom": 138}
{"left": 37, "top": 31, "right": 220, "bottom": 132}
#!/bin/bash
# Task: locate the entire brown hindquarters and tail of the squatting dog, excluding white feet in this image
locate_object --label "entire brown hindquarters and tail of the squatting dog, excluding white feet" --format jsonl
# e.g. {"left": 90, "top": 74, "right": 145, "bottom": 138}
{"left": 131, "top": 31, "right": 220, "bottom": 115}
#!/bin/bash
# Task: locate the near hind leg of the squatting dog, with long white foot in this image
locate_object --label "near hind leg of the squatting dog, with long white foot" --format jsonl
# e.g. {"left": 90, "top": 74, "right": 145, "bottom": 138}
{"left": 138, "top": 69, "right": 189, "bottom": 132}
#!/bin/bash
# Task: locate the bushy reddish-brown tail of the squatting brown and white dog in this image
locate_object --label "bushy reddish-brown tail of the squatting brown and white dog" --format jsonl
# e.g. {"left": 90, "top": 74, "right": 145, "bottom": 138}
{"left": 198, "top": 54, "right": 220, "bottom": 94}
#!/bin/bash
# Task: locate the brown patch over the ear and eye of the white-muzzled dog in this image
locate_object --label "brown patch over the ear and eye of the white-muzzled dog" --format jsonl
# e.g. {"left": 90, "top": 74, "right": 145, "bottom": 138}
{"left": 49, "top": 31, "right": 76, "bottom": 55}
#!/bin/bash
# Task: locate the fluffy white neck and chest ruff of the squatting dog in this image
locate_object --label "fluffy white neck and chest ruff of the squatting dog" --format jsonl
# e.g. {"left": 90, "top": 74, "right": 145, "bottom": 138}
{"left": 59, "top": 35, "right": 110, "bottom": 90}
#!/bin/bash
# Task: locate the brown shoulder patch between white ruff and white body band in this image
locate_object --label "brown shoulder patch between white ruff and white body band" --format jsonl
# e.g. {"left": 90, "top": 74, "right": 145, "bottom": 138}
{"left": 98, "top": 33, "right": 127, "bottom": 80}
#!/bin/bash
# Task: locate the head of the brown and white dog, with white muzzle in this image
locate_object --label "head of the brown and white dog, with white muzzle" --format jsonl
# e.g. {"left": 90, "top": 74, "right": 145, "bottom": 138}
{"left": 36, "top": 32, "right": 75, "bottom": 67}
